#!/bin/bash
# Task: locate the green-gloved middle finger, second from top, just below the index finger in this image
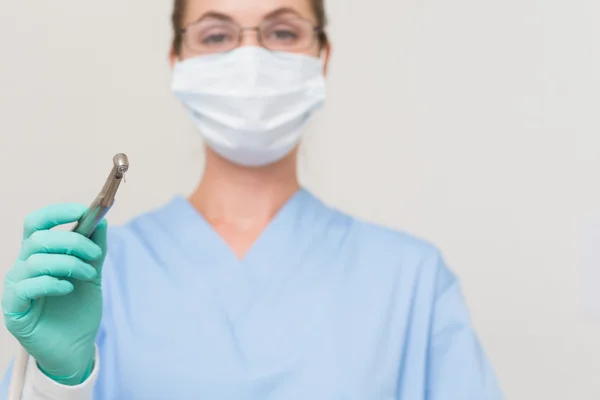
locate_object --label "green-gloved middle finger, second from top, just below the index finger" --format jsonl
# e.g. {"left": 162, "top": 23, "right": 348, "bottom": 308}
{"left": 19, "top": 231, "right": 102, "bottom": 261}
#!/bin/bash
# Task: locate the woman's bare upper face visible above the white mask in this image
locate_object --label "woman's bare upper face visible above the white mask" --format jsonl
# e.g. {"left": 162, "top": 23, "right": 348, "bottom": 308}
{"left": 173, "top": 0, "right": 329, "bottom": 64}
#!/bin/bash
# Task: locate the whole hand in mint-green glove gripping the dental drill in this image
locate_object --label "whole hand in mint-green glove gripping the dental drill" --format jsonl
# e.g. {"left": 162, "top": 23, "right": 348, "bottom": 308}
{"left": 2, "top": 204, "right": 107, "bottom": 385}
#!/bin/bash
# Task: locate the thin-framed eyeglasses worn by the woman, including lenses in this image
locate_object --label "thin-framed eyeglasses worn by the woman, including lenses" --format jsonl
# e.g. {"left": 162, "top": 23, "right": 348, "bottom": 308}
{"left": 181, "top": 16, "right": 322, "bottom": 54}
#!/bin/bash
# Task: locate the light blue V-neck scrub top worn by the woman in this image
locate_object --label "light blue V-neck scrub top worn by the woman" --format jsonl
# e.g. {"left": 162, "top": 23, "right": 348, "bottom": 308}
{"left": 0, "top": 190, "right": 503, "bottom": 400}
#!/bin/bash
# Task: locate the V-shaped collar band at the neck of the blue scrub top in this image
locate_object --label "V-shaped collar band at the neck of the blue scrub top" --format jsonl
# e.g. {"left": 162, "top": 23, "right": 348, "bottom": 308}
{"left": 152, "top": 189, "right": 321, "bottom": 325}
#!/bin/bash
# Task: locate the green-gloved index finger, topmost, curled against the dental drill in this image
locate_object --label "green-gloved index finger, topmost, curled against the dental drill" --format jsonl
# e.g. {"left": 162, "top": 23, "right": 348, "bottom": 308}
{"left": 23, "top": 203, "right": 87, "bottom": 239}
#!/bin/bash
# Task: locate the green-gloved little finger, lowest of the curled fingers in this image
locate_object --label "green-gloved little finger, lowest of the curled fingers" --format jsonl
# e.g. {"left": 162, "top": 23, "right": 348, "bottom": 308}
{"left": 2, "top": 276, "right": 74, "bottom": 315}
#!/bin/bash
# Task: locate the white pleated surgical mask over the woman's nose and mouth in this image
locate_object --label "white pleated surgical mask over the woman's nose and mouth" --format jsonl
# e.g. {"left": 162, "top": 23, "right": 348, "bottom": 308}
{"left": 172, "top": 46, "right": 325, "bottom": 166}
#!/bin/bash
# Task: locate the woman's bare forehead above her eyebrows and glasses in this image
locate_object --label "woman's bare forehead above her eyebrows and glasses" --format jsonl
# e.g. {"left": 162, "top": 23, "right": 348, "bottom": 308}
{"left": 185, "top": 0, "right": 315, "bottom": 25}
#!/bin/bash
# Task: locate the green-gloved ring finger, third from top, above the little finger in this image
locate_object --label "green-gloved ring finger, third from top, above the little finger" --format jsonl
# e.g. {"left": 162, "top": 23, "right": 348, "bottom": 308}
{"left": 6, "top": 253, "right": 98, "bottom": 282}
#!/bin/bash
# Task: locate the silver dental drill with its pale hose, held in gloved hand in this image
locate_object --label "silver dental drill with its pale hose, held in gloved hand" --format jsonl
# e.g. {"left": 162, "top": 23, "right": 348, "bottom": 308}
{"left": 8, "top": 153, "right": 129, "bottom": 400}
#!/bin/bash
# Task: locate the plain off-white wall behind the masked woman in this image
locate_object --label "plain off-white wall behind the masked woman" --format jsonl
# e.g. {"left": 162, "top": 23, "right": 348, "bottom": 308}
{"left": 0, "top": 0, "right": 600, "bottom": 400}
